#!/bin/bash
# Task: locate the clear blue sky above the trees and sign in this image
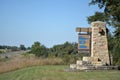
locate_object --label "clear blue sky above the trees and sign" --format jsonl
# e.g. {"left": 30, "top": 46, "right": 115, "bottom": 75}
{"left": 0, "top": 0, "right": 100, "bottom": 48}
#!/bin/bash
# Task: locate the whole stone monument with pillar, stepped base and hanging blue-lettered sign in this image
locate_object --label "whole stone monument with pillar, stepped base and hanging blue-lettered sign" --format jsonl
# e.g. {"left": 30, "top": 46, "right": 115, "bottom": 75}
{"left": 70, "top": 21, "right": 118, "bottom": 70}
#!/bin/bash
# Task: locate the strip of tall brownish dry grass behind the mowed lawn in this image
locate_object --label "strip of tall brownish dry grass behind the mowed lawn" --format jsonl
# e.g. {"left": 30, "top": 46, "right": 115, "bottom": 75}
{"left": 0, "top": 55, "right": 63, "bottom": 73}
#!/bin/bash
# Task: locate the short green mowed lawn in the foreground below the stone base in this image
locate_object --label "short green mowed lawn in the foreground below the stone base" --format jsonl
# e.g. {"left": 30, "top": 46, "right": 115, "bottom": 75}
{"left": 0, "top": 65, "right": 120, "bottom": 80}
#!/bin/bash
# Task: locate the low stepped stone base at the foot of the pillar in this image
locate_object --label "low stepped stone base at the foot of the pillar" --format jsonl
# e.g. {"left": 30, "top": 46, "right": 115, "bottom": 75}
{"left": 69, "top": 60, "right": 118, "bottom": 71}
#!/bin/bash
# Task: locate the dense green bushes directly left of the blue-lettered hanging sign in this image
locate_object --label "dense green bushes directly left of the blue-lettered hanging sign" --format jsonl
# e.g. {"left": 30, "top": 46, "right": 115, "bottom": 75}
{"left": 49, "top": 42, "right": 78, "bottom": 64}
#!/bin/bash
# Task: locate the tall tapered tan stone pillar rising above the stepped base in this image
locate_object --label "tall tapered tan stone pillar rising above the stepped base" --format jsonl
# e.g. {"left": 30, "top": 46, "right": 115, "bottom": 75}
{"left": 91, "top": 21, "right": 110, "bottom": 65}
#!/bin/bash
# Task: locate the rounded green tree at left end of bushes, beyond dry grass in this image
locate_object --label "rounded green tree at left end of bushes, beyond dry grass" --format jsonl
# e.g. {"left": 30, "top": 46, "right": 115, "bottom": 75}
{"left": 31, "top": 41, "right": 48, "bottom": 57}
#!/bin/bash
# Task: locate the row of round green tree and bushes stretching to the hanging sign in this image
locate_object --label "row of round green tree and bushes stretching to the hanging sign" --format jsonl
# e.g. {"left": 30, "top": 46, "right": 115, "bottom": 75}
{"left": 30, "top": 41, "right": 78, "bottom": 63}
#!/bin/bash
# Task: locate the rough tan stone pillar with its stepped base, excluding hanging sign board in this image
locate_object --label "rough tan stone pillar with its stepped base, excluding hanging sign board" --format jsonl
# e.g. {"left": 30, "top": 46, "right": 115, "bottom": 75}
{"left": 70, "top": 21, "right": 110, "bottom": 70}
